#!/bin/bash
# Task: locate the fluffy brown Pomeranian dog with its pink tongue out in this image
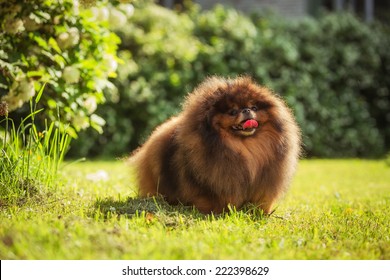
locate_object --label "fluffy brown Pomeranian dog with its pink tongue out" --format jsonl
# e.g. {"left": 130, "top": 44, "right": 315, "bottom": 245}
{"left": 131, "top": 77, "right": 300, "bottom": 214}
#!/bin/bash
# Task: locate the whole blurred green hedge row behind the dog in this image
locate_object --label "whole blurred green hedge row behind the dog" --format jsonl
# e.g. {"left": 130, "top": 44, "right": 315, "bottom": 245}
{"left": 68, "top": 2, "right": 390, "bottom": 157}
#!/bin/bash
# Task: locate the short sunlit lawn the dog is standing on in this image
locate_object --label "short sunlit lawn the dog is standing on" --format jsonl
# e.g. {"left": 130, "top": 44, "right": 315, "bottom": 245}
{"left": 0, "top": 160, "right": 390, "bottom": 259}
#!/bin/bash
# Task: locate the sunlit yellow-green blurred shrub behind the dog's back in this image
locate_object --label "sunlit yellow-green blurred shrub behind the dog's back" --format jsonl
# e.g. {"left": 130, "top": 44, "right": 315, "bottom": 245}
{"left": 70, "top": 5, "right": 204, "bottom": 156}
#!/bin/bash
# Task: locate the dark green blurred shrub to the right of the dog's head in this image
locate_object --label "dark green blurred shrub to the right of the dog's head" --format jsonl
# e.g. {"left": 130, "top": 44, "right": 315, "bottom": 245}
{"left": 253, "top": 14, "right": 385, "bottom": 157}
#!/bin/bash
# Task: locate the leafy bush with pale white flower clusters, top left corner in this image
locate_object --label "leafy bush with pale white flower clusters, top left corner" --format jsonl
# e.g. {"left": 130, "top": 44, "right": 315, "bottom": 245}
{"left": 0, "top": 0, "right": 119, "bottom": 137}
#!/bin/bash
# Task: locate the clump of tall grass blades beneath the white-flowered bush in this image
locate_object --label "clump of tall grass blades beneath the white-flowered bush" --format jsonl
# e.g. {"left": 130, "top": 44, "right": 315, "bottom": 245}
{"left": 0, "top": 87, "right": 71, "bottom": 207}
